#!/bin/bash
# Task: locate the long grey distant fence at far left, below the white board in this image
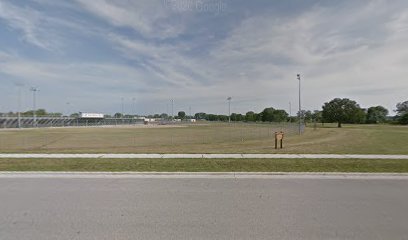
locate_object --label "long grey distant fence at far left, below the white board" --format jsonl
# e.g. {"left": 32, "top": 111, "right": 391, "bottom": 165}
{"left": 0, "top": 117, "right": 143, "bottom": 128}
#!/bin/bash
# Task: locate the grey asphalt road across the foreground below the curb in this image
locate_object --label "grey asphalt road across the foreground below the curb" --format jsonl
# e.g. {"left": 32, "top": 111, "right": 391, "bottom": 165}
{"left": 0, "top": 175, "right": 408, "bottom": 240}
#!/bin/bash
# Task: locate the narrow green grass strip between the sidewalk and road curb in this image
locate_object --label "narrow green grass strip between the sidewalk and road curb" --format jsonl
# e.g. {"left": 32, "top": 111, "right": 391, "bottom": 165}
{"left": 0, "top": 159, "right": 408, "bottom": 173}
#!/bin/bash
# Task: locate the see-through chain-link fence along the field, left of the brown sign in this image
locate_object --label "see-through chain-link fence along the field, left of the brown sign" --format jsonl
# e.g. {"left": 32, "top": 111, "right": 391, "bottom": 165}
{"left": 0, "top": 119, "right": 304, "bottom": 153}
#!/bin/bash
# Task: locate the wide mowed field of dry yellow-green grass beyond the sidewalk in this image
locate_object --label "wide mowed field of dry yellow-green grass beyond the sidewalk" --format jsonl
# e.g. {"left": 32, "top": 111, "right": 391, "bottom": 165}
{"left": 0, "top": 123, "right": 408, "bottom": 154}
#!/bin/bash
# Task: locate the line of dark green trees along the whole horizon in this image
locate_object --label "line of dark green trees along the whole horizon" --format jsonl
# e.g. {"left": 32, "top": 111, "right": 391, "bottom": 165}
{"left": 0, "top": 98, "right": 408, "bottom": 127}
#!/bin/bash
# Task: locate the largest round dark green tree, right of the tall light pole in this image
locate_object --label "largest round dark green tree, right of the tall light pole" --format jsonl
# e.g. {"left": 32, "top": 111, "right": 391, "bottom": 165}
{"left": 322, "top": 98, "right": 365, "bottom": 128}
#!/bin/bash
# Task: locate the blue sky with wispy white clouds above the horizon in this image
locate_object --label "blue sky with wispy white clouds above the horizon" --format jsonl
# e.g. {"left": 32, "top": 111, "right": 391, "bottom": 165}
{"left": 0, "top": 0, "right": 408, "bottom": 115}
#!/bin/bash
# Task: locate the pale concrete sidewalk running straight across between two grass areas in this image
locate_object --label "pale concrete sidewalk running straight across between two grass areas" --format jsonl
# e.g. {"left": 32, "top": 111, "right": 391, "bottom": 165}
{"left": 0, "top": 153, "right": 408, "bottom": 159}
